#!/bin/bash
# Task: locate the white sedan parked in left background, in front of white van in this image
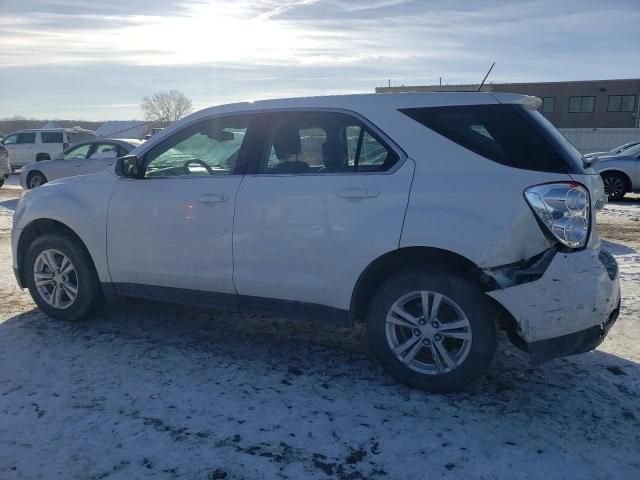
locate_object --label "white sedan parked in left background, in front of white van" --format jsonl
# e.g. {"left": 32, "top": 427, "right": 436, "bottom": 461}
{"left": 20, "top": 139, "right": 142, "bottom": 189}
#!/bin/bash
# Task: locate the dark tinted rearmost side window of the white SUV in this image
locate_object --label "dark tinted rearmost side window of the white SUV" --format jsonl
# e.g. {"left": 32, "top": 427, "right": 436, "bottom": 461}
{"left": 401, "top": 105, "right": 575, "bottom": 173}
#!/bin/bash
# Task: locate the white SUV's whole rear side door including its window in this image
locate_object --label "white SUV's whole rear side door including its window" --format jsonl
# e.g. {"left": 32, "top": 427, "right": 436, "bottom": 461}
{"left": 233, "top": 111, "right": 414, "bottom": 309}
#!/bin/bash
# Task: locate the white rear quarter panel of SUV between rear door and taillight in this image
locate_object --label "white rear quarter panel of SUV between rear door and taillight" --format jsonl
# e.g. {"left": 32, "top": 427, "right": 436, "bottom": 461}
{"left": 400, "top": 144, "right": 571, "bottom": 269}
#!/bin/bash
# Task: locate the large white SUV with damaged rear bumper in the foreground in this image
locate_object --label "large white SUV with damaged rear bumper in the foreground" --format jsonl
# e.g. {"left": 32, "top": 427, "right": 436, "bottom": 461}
{"left": 12, "top": 93, "right": 620, "bottom": 391}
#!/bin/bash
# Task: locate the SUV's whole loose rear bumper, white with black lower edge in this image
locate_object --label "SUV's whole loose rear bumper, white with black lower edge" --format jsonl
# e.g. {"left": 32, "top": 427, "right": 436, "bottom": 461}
{"left": 488, "top": 248, "right": 620, "bottom": 363}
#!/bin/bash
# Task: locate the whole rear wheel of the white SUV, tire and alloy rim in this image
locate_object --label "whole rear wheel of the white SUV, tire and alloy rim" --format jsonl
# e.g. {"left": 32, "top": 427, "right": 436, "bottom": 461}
{"left": 367, "top": 271, "right": 497, "bottom": 392}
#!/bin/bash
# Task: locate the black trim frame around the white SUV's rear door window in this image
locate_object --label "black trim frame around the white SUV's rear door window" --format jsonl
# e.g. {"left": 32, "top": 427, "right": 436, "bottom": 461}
{"left": 247, "top": 107, "right": 408, "bottom": 177}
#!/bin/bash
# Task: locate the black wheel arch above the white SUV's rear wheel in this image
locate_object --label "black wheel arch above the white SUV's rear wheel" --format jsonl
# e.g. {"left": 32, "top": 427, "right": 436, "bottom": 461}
{"left": 349, "top": 247, "right": 519, "bottom": 333}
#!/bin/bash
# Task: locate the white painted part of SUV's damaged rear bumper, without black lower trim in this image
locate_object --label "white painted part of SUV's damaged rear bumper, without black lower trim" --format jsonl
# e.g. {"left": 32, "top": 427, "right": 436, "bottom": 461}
{"left": 488, "top": 248, "right": 620, "bottom": 343}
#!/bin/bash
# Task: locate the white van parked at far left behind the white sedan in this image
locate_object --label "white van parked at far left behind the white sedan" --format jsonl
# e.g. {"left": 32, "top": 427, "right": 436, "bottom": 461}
{"left": 2, "top": 128, "right": 95, "bottom": 169}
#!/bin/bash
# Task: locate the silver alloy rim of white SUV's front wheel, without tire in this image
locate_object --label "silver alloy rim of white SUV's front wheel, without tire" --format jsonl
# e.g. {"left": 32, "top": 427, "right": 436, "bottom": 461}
{"left": 33, "top": 249, "right": 78, "bottom": 310}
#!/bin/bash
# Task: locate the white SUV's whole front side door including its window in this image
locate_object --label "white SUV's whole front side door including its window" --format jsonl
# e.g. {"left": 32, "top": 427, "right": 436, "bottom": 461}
{"left": 107, "top": 116, "right": 250, "bottom": 293}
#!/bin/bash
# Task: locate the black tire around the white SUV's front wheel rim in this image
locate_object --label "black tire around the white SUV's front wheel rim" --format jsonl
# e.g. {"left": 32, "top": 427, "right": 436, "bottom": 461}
{"left": 23, "top": 233, "right": 104, "bottom": 321}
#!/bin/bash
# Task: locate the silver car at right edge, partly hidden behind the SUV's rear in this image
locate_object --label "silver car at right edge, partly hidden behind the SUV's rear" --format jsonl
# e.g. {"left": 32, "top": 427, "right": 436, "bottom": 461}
{"left": 594, "top": 144, "right": 640, "bottom": 200}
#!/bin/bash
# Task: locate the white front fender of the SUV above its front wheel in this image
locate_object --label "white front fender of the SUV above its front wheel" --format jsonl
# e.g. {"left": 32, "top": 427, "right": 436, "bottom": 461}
{"left": 12, "top": 171, "right": 117, "bottom": 282}
